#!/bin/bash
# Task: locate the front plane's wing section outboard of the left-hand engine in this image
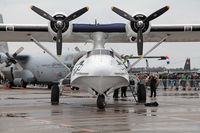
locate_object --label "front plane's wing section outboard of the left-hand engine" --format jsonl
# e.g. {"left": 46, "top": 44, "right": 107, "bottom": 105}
{"left": 0, "top": 24, "right": 52, "bottom": 42}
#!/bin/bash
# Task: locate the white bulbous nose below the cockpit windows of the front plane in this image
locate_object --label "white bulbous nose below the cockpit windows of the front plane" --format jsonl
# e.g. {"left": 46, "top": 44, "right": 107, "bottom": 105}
{"left": 71, "top": 56, "right": 129, "bottom": 94}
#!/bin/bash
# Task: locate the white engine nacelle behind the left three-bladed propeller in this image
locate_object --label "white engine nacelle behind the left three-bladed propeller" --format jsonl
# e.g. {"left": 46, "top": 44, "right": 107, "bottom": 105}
{"left": 48, "top": 13, "right": 73, "bottom": 40}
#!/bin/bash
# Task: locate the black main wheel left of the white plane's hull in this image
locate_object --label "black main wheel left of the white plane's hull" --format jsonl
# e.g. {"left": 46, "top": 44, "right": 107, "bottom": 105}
{"left": 51, "top": 84, "right": 59, "bottom": 105}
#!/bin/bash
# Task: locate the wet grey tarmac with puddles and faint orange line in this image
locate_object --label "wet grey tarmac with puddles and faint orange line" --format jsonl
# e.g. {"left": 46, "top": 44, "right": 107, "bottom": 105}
{"left": 0, "top": 88, "right": 200, "bottom": 133}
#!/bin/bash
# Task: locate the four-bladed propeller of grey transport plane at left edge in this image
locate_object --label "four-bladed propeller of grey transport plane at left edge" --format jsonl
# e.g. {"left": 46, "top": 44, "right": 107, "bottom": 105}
{"left": 0, "top": 45, "right": 24, "bottom": 72}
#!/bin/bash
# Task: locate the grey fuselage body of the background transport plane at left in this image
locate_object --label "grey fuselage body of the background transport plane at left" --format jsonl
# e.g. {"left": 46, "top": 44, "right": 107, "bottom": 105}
{"left": 1, "top": 52, "right": 77, "bottom": 84}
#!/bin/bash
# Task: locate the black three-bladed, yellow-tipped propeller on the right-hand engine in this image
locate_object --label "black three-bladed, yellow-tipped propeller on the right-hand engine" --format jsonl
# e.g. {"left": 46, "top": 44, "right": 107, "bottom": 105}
{"left": 111, "top": 6, "right": 170, "bottom": 57}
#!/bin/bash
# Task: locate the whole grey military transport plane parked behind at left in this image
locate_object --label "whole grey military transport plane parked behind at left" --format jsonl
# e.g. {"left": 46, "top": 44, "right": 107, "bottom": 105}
{"left": 0, "top": 46, "right": 77, "bottom": 89}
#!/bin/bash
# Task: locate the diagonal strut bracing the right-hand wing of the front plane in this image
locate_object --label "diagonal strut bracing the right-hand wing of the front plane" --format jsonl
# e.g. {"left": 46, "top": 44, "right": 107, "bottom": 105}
{"left": 127, "top": 35, "right": 170, "bottom": 71}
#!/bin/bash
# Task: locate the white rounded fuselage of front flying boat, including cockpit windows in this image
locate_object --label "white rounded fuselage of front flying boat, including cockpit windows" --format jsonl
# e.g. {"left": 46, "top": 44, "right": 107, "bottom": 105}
{"left": 71, "top": 49, "right": 129, "bottom": 94}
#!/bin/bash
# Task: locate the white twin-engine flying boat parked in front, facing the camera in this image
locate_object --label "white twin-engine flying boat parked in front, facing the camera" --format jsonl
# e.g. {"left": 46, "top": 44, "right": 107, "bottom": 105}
{"left": 0, "top": 6, "right": 200, "bottom": 108}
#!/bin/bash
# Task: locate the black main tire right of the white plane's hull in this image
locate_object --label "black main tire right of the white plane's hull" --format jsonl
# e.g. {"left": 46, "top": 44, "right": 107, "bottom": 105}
{"left": 137, "top": 84, "right": 146, "bottom": 103}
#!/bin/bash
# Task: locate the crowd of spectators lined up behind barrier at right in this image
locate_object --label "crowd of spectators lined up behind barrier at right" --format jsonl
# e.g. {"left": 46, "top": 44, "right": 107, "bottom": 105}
{"left": 136, "top": 73, "right": 200, "bottom": 91}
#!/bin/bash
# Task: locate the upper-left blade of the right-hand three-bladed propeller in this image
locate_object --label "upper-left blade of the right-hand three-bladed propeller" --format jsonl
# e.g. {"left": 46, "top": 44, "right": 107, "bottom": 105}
{"left": 111, "top": 6, "right": 137, "bottom": 22}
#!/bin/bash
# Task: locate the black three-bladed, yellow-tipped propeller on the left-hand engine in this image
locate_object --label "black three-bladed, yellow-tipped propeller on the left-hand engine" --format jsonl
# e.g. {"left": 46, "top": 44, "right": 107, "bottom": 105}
{"left": 30, "top": 5, "right": 89, "bottom": 57}
